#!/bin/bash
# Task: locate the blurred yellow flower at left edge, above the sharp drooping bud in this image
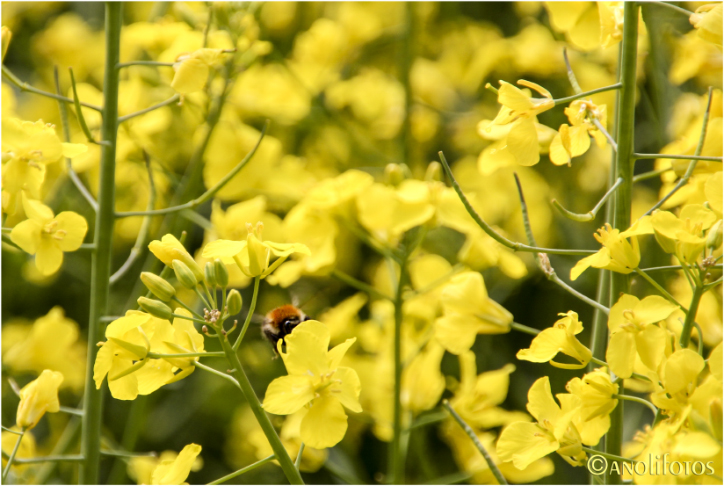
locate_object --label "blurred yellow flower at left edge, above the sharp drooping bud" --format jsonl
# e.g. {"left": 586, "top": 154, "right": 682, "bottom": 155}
{"left": 2, "top": 306, "right": 86, "bottom": 390}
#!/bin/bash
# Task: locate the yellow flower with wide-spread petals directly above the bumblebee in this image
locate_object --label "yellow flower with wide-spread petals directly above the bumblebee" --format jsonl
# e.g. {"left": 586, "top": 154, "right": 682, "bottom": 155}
{"left": 202, "top": 222, "right": 310, "bottom": 278}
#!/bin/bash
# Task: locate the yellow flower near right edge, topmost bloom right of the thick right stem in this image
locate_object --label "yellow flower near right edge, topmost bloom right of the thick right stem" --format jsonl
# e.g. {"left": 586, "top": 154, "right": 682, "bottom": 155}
{"left": 651, "top": 204, "right": 717, "bottom": 263}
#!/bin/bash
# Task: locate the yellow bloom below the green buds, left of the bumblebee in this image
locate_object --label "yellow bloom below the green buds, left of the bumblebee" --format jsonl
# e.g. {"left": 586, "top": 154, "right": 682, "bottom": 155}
{"left": 93, "top": 308, "right": 204, "bottom": 400}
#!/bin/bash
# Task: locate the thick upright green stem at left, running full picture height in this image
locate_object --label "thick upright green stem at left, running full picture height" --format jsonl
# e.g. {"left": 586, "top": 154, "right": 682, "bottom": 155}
{"left": 80, "top": 2, "right": 123, "bottom": 484}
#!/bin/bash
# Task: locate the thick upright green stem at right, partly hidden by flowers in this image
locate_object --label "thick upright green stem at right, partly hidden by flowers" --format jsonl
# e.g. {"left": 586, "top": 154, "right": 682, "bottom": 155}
{"left": 606, "top": 2, "right": 639, "bottom": 484}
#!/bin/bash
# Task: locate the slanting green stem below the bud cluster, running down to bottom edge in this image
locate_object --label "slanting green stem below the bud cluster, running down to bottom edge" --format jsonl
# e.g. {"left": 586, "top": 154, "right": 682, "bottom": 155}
{"left": 218, "top": 335, "right": 304, "bottom": 484}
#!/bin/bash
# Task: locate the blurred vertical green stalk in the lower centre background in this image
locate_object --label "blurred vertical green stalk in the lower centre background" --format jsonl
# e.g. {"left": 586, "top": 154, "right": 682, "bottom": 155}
{"left": 389, "top": 253, "right": 408, "bottom": 484}
